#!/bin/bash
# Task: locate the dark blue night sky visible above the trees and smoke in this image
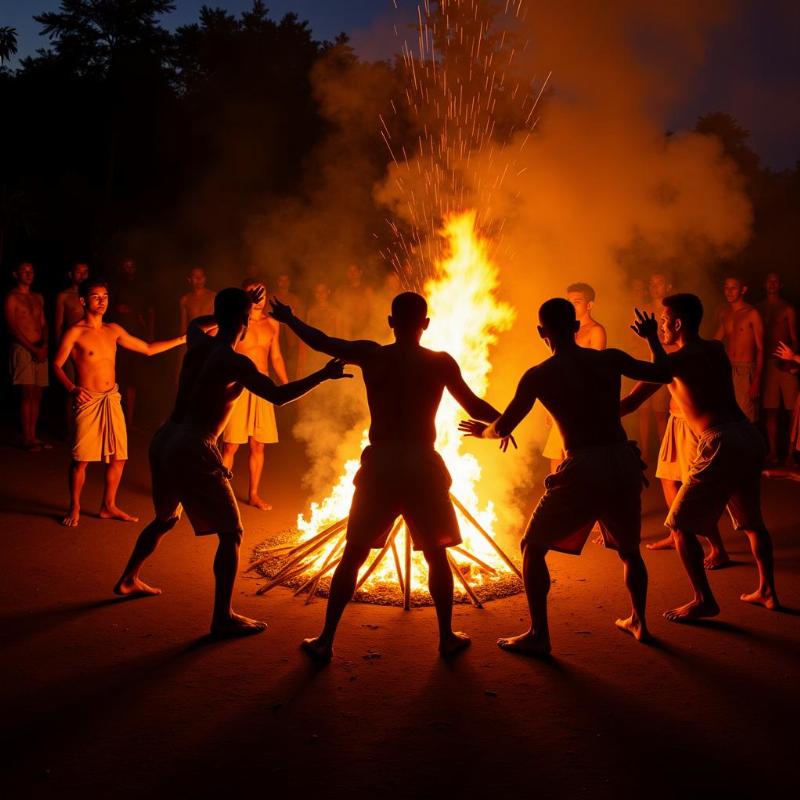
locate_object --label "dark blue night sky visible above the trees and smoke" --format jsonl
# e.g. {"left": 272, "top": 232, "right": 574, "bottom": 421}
{"left": 0, "top": 0, "right": 800, "bottom": 169}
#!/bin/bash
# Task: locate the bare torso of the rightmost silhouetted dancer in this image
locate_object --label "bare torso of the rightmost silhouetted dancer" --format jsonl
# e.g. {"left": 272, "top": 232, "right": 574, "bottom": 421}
{"left": 669, "top": 339, "right": 745, "bottom": 435}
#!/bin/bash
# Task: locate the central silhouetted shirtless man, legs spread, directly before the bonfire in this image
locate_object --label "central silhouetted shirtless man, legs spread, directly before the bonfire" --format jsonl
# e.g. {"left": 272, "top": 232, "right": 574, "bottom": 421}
{"left": 271, "top": 292, "right": 507, "bottom": 661}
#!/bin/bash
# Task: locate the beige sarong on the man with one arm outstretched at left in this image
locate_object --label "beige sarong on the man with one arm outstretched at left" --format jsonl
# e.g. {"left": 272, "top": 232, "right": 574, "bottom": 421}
{"left": 72, "top": 384, "right": 128, "bottom": 462}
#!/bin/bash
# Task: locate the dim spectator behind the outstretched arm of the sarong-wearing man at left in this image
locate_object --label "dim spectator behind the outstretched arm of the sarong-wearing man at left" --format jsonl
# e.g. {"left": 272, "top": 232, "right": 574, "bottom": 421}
{"left": 113, "top": 258, "right": 155, "bottom": 428}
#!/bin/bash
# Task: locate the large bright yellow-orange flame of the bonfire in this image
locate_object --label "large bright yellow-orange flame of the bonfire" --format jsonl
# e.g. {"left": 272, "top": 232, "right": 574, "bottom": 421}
{"left": 297, "top": 211, "right": 515, "bottom": 592}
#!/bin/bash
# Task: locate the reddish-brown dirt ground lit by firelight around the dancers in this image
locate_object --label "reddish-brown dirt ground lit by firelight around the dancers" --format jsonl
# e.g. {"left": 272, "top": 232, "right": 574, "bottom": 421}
{"left": 0, "top": 422, "right": 800, "bottom": 798}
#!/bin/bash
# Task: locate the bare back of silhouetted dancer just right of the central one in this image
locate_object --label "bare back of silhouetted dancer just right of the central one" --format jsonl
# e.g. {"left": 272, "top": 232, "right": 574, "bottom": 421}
{"left": 536, "top": 347, "right": 627, "bottom": 451}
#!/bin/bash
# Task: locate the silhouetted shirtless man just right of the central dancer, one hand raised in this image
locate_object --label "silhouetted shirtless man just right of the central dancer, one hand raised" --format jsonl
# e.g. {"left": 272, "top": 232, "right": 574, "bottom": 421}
{"left": 459, "top": 298, "right": 670, "bottom": 656}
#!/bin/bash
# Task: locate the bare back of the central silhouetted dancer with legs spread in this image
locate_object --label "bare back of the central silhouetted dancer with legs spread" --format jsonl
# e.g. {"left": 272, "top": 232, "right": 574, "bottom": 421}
{"left": 362, "top": 342, "right": 452, "bottom": 447}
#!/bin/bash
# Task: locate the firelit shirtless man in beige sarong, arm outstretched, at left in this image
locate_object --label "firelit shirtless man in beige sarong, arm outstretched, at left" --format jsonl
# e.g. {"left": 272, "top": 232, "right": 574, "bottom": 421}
{"left": 53, "top": 279, "right": 186, "bottom": 528}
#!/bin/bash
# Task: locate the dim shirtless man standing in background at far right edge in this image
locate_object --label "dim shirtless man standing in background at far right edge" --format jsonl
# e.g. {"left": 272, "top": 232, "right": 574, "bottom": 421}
{"left": 758, "top": 272, "right": 798, "bottom": 466}
